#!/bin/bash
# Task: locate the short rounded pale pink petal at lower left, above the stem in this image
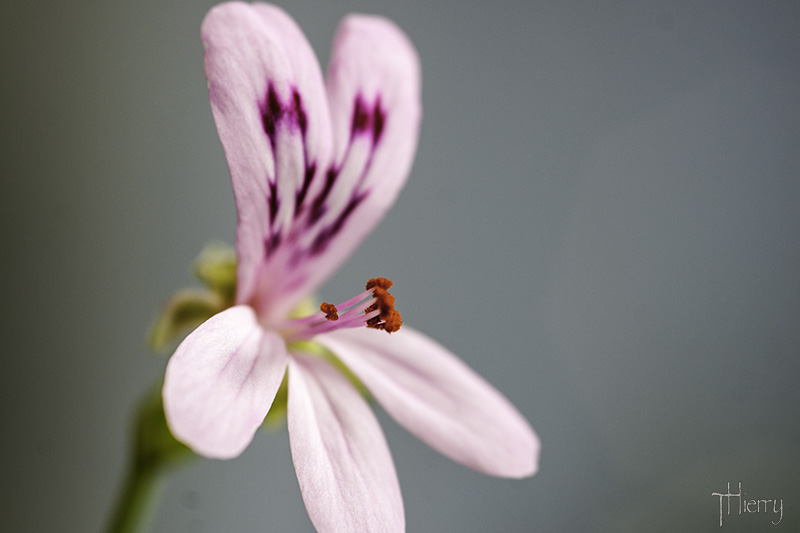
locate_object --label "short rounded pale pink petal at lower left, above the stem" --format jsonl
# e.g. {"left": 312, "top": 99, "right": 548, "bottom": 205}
{"left": 163, "top": 306, "right": 287, "bottom": 459}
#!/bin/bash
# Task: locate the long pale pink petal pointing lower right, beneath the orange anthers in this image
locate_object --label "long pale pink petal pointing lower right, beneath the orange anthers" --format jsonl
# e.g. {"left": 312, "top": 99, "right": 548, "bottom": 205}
{"left": 316, "top": 326, "right": 540, "bottom": 477}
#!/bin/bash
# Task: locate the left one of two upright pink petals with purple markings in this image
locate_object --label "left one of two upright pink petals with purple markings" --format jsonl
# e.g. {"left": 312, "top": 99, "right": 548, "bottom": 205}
{"left": 202, "top": 2, "right": 332, "bottom": 312}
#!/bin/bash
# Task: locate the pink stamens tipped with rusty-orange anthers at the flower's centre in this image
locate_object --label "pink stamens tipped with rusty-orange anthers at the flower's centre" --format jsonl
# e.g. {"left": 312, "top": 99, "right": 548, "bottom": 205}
{"left": 281, "top": 278, "right": 403, "bottom": 341}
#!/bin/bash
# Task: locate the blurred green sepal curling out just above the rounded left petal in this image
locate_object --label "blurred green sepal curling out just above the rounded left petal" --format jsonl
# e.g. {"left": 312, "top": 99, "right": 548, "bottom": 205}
{"left": 147, "top": 289, "right": 226, "bottom": 352}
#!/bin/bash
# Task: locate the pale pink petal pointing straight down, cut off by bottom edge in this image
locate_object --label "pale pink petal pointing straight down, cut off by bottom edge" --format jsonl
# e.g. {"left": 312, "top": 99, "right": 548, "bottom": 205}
{"left": 288, "top": 356, "right": 405, "bottom": 533}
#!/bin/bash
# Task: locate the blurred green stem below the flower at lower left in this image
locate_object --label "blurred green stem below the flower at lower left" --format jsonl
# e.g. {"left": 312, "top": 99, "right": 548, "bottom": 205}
{"left": 108, "top": 385, "right": 194, "bottom": 533}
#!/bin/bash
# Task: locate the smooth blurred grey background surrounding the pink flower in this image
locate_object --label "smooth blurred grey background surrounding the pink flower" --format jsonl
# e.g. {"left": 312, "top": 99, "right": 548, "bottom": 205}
{"left": 0, "top": 0, "right": 800, "bottom": 532}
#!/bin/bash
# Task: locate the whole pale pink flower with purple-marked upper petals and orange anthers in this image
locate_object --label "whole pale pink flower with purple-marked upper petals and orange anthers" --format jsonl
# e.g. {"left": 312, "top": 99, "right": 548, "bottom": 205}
{"left": 163, "top": 2, "right": 539, "bottom": 532}
